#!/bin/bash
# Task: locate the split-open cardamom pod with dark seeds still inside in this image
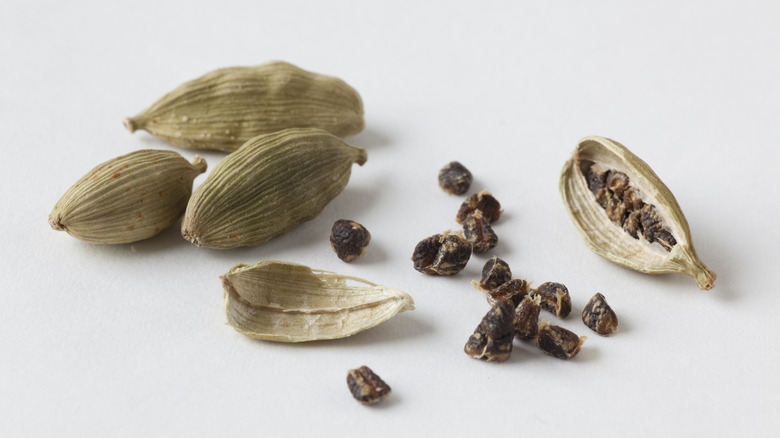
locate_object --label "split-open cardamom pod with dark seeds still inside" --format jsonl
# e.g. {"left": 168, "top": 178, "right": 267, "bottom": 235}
{"left": 560, "top": 137, "right": 716, "bottom": 290}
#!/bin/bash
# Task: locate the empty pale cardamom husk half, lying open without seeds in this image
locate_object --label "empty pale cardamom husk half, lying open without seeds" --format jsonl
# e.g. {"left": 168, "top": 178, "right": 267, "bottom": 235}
{"left": 220, "top": 260, "right": 414, "bottom": 342}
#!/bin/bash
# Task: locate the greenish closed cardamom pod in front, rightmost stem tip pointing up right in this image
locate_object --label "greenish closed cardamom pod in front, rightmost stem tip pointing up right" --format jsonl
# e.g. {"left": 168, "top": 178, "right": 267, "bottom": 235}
{"left": 182, "top": 128, "right": 366, "bottom": 249}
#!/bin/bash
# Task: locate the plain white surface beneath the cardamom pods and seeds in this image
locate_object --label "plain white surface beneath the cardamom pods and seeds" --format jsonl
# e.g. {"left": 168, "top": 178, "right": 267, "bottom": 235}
{"left": 0, "top": 1, "right": 780, "bottom": 437}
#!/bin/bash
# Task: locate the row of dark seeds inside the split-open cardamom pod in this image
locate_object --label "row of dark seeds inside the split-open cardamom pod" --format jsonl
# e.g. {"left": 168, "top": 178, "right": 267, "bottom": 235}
{"left": 583, "top": 162, "right": 677, "bottom": 251}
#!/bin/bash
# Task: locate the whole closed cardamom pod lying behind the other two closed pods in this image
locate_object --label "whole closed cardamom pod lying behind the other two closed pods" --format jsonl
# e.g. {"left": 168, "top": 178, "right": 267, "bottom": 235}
{"left": 124, "top": 61, "right": 364, "bottom": 152}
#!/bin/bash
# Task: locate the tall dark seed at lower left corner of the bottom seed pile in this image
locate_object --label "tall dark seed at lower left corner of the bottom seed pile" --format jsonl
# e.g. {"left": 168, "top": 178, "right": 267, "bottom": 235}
{"left": 463, "top": 301, "right": 515, "bottom": 362}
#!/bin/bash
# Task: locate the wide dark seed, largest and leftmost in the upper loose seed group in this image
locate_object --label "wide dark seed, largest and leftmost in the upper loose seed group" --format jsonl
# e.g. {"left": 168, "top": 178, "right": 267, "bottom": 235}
{"left": 412, "top": 232, "right": 471, "bottom": 275}
